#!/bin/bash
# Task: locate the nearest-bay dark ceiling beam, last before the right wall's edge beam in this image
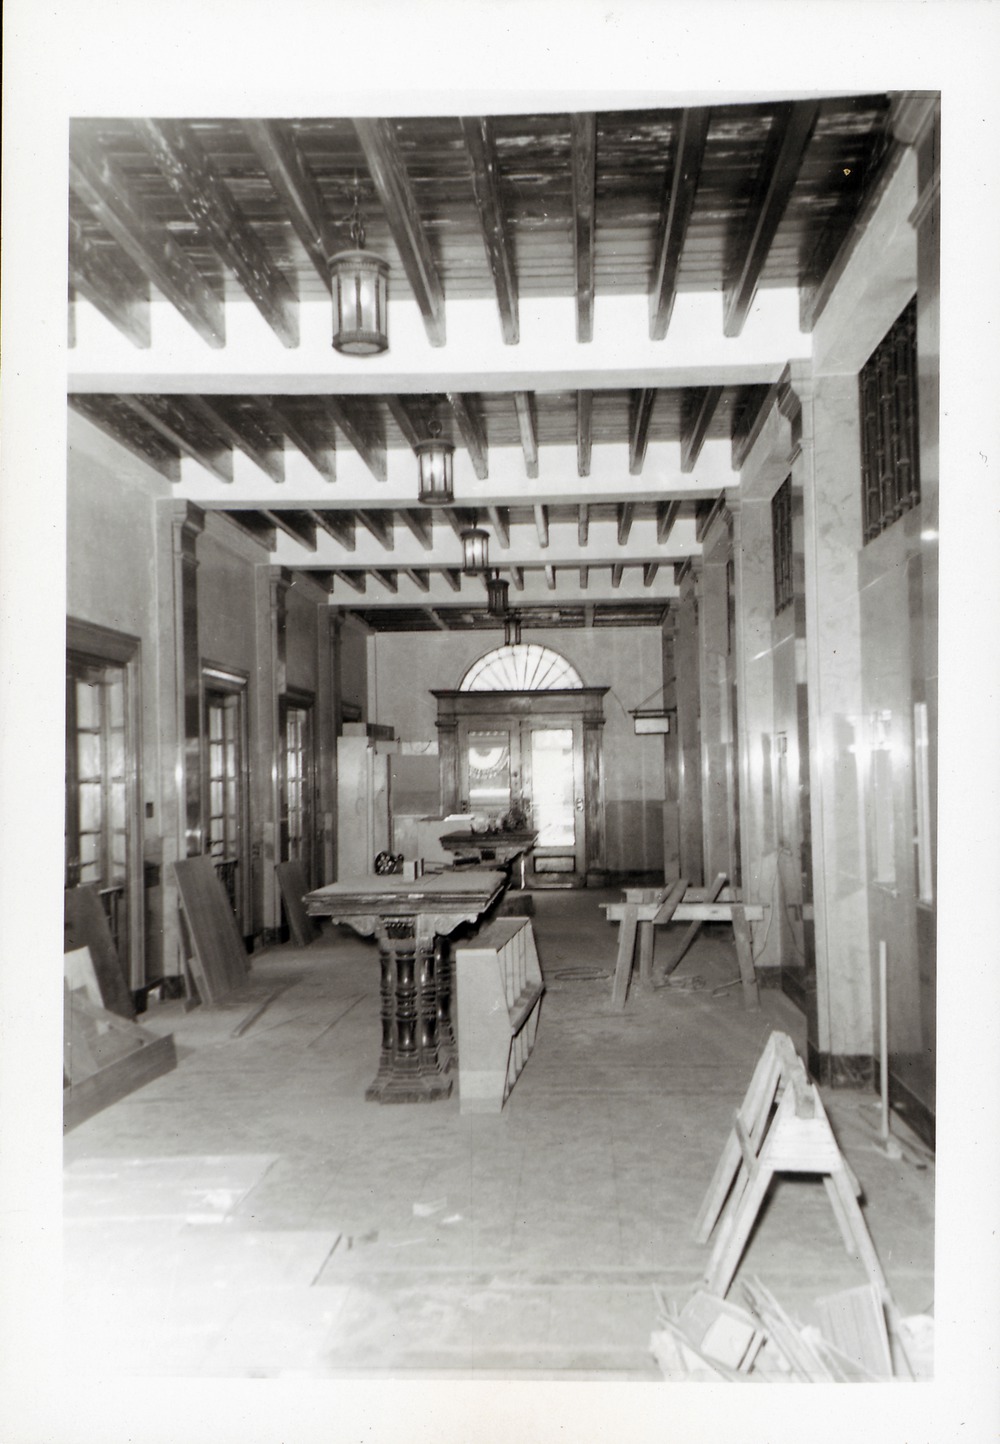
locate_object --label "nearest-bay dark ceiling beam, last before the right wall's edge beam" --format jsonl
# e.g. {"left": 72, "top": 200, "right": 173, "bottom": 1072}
{"left": 723, "top": 100, "right": 820, "bottom": 336}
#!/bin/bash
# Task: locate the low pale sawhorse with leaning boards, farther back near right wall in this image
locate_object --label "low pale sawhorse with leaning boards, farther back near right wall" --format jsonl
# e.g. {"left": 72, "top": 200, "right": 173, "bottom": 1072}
{"left": 602, "top": 874, "right": 763, "bottom": 1009}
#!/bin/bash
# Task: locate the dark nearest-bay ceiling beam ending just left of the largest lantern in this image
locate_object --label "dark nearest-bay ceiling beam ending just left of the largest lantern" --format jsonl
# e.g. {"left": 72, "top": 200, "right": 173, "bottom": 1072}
{"left": 133, "top": 117, "right": 299, "bottom": 347}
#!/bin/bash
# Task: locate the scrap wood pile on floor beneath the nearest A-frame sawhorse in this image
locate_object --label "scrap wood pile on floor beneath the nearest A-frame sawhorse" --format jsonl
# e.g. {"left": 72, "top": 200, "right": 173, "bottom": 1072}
{"left": 649, "top": 1278, "right": 929, "bottom": 1383}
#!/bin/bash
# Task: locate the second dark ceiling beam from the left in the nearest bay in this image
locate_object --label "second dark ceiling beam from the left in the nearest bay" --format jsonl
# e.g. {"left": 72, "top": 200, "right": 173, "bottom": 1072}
{"left": 69, "top": 132, "right": 225, "bottom": 349}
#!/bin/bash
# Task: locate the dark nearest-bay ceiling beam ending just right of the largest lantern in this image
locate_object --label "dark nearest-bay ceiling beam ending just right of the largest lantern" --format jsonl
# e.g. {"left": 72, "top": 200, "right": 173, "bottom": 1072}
{"left": 354, "top": 118, "right": 444, "bottom": 347}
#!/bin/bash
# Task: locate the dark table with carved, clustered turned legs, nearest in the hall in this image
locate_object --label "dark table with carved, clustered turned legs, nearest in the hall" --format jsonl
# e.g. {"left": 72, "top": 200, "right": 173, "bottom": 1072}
{"left": 303, "top": 869, "right": 506, "bottom": 1103}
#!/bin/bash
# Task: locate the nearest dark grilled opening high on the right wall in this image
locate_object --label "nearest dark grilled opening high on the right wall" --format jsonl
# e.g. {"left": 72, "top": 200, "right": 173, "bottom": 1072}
{"left": 859, "top": 300, "right": 921, "bottom": 542}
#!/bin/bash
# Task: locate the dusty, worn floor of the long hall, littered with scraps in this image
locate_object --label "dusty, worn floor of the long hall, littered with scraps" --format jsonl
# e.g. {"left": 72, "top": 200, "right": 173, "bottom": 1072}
{"left": 65, "top": 892, "right": 934, "bottom": 1382}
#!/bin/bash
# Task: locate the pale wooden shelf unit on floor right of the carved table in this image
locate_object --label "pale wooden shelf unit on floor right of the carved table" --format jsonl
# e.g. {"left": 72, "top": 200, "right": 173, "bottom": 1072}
{"left": 455, "top": 917, "right": 545, "bottom": 1113}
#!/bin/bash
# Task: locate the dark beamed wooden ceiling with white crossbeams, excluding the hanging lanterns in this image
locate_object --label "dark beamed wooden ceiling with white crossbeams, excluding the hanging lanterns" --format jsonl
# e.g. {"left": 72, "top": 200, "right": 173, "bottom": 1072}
{"left": 69, "top": 94, "right": 903, "bottom": 630}
